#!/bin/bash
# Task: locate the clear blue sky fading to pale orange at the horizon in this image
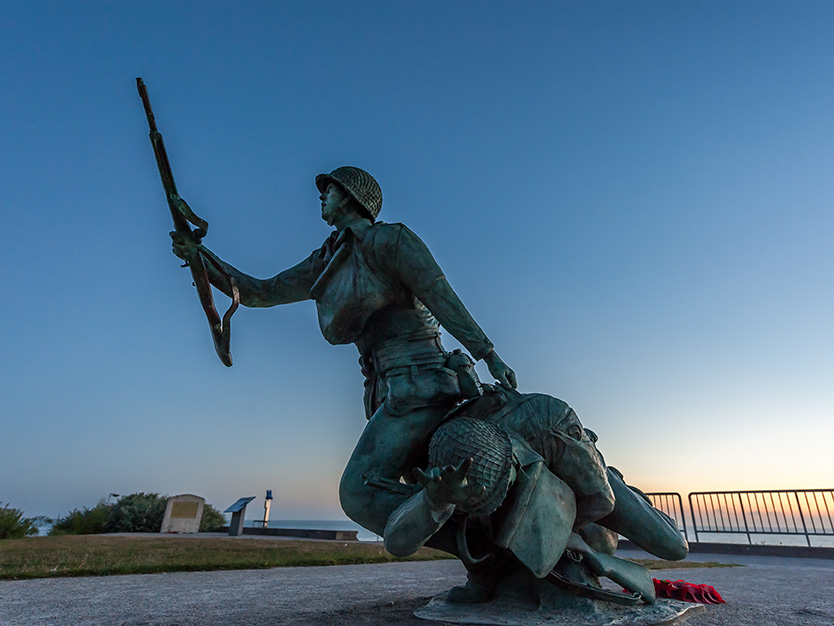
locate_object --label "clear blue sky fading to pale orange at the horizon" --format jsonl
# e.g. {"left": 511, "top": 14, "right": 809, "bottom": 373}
{"left": 0, "top": 0, "right": 834, "bottom": 519}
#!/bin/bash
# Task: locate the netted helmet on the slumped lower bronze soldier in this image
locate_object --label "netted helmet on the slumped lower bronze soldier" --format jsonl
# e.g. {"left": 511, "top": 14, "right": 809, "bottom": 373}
{"left": 429, "top": 417, "right": 513, "bottom": 515}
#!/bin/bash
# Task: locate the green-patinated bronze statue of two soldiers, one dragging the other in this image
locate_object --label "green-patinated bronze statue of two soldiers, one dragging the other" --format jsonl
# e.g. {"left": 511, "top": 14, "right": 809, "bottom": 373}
{"left": 145, "top": 85, "right": 704, "bottom": 624}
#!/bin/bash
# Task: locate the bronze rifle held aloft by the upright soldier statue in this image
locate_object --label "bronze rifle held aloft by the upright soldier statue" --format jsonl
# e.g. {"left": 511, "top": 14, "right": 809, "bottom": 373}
{"left": 136, "top": 78, "right": 240, "bottom": 367}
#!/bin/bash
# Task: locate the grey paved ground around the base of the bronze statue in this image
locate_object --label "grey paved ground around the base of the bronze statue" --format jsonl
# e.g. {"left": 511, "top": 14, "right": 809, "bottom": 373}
{"left": 0, "top": 552, "right": 834, "bottom": 626}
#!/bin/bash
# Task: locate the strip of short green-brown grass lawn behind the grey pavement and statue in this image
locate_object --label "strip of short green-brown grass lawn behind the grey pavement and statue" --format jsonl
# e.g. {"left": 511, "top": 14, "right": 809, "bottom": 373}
{"left": 0, "top": 534, "right": 732, "bottom": 580}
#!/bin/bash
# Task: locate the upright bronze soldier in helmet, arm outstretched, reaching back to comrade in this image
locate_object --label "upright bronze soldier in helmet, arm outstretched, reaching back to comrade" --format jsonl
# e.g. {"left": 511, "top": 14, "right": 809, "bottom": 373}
{"left": 171, "top": 167, "right": 516, "bottom": 552}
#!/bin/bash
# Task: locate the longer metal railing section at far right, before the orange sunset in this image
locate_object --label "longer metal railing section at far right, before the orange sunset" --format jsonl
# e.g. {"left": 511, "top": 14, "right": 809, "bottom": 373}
{"left": 689, "top": 489, "right": 834, "bottom": 546}
